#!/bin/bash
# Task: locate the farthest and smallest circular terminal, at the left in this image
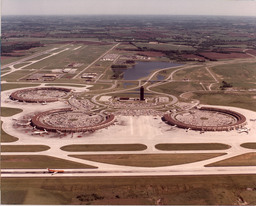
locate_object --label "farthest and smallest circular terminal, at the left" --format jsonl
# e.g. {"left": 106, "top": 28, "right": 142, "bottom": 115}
{"left": 10, "top": 87, "right": 71, "bottom": 103}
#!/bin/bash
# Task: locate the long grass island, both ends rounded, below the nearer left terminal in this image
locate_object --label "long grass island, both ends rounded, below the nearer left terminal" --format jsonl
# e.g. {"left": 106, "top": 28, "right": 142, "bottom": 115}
{"left": 61, "top": 144, "right": 147, "bottom": 152}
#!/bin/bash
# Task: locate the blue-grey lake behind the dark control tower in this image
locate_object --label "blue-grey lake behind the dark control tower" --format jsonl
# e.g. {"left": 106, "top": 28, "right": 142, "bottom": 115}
{"left": 123, "top": 61, "right": 181, "bottom": 80}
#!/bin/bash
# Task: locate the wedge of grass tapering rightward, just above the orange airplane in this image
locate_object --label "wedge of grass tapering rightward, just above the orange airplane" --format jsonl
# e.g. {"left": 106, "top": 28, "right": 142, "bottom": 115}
{"left": 1, "top": 155, "right": 95, "bottom": 169}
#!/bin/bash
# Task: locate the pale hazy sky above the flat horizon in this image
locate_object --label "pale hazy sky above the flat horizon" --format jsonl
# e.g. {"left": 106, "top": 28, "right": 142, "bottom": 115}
{"left": 2, "top": 0, "right": 256, "bottom": 16}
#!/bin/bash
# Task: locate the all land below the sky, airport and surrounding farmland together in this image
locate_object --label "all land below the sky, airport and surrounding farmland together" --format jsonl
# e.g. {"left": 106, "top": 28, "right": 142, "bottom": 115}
{"left": 1, "top": 16, "right": 256, "bottom": 205}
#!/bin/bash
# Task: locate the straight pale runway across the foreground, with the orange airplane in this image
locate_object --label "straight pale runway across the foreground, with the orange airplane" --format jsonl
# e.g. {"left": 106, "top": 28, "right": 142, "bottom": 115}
{"left": 1, "top": 166, "right": 256, "bottom": 178}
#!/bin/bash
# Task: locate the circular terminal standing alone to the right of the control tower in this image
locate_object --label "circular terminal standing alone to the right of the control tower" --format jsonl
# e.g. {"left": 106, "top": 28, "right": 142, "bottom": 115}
{"left": 163, "top": 107, "right": 246, "bottom": 131}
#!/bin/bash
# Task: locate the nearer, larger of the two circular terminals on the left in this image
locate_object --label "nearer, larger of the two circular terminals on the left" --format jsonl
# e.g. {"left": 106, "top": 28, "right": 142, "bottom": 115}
{"left": 31, "top": 109, "right": 115, "bottom": 132}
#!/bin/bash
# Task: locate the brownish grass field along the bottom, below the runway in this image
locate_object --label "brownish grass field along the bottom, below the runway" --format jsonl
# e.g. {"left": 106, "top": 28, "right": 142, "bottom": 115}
{"left": 1, "top": 175, "right": 256, "bottom": 205}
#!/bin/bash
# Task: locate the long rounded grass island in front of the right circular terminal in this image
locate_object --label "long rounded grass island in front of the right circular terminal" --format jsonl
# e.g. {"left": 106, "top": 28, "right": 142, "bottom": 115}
{"left": 155, "top": 143, "right": 230, "bottom": 151}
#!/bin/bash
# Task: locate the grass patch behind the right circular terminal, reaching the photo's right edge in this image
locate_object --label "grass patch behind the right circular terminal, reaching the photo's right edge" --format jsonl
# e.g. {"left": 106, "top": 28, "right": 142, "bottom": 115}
{"left": 192, "top": 92, "right": 256, "bottom": 111}
